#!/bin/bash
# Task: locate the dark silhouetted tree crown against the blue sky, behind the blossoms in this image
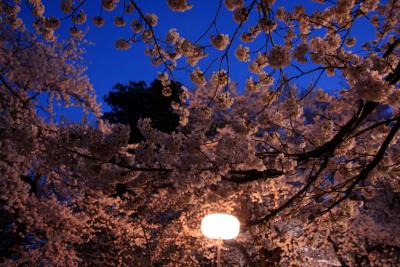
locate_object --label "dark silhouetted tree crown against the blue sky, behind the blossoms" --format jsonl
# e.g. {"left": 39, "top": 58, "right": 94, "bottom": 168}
{"left": 104, "top": 80, "right": 182, "bottom": 143}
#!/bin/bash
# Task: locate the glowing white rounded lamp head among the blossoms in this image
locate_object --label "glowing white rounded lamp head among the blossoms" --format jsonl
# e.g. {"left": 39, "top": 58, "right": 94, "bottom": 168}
{"left": 201, "top": 213, "right": 240, "bottom": 239}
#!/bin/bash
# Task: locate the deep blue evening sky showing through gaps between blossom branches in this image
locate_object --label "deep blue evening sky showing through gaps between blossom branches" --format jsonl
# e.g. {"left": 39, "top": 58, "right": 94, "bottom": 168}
{"left": 24, "top": 0, "right": 373, "bottom": 120}
